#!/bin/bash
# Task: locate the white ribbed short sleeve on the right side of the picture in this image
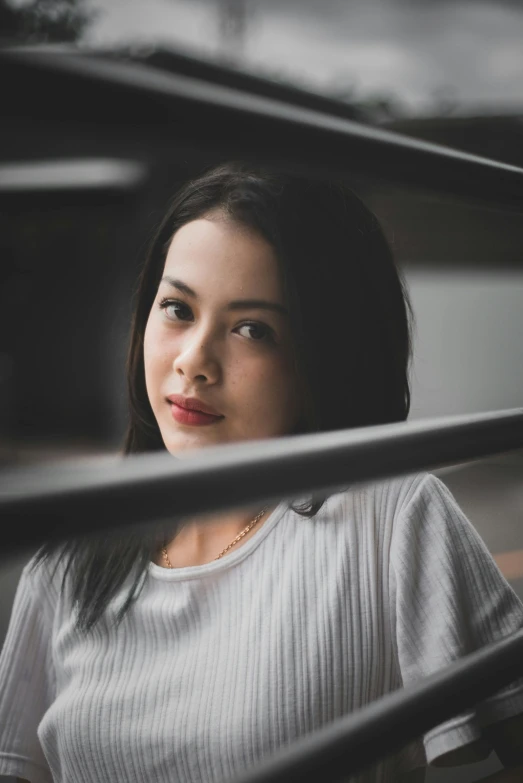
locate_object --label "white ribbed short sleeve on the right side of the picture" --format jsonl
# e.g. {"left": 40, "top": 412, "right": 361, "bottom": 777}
{"left": 391, "top": 474, "right": 523, "bottom": 763}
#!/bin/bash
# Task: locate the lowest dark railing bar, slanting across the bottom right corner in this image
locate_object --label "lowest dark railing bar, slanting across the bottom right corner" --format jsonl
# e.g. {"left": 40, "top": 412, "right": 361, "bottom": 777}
{"left": 232, "top": 630, "right": 523, "bottom": 783}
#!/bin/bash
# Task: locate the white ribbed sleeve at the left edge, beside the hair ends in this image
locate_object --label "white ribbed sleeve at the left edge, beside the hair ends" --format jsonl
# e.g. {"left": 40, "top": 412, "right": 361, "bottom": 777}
{"left": 0, "top": 561, "right": 55, "bottom": 783}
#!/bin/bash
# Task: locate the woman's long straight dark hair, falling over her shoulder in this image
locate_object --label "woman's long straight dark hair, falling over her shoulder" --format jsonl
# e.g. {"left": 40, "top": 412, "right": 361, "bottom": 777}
{"left": 37, "top": 163, "right": 411, "bottom": 631}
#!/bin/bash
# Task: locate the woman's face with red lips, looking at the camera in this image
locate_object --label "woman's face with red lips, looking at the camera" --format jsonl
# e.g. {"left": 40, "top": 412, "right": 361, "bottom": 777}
{"left": 144, "top": 213, "right": 300, "bottom": 454}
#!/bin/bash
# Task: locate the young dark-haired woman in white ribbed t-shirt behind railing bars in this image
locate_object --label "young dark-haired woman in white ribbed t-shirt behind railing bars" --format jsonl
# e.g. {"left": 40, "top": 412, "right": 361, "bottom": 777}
{"left": 0, "top": 164, "right": 523, "bottom": 783}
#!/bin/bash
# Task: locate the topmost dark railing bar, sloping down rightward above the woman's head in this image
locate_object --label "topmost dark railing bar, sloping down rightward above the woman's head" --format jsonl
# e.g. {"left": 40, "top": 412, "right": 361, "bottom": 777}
{"left": 0, "top": 50, "right": 523, "bottom": 208}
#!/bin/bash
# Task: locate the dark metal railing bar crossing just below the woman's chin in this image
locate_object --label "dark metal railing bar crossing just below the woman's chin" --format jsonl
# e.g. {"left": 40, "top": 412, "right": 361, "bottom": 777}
{"left": 0, "top": 409, "right": 523, "bottom": 555}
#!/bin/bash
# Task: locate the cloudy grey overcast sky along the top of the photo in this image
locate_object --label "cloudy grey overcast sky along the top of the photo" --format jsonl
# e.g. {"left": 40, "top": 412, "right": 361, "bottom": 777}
{"left": 86, "top": 0, "right": 523, "bottom": 113}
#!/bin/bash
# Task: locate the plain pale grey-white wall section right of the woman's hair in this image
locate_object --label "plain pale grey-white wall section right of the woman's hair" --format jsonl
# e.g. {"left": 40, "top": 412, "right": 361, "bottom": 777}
{"left": 406, "top": 268, "right": 523, "bottom": 419}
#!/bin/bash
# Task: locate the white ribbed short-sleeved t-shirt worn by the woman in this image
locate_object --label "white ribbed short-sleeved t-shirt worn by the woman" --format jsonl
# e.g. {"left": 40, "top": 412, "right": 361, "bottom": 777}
{"left": 0, "top": 474, "right": 523, "bottom": 783}
